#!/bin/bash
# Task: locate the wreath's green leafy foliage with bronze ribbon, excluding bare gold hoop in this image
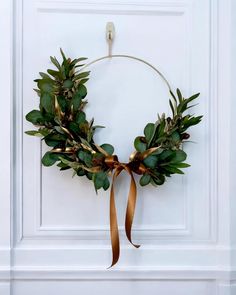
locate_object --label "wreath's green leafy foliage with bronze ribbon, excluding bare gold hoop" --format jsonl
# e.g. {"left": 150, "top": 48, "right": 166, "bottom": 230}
{"left": 26, "top": 50, "right": 202, "bottom": 266}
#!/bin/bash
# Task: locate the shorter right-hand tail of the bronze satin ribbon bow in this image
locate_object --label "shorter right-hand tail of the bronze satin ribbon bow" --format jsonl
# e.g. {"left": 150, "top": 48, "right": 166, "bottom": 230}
{"left": 125, "top": 167, "right": 140, "bottom": 248}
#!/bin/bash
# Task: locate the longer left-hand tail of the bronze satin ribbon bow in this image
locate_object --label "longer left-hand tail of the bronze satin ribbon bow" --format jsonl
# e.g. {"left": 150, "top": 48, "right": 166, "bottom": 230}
{"left": 108, "top": 168, "right": 121, "bottom": 268}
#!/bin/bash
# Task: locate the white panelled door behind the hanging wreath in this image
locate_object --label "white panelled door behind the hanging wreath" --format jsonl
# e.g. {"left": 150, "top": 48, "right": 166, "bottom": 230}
{"left": 0, "top": 0, "right": 235, "bottom": 295}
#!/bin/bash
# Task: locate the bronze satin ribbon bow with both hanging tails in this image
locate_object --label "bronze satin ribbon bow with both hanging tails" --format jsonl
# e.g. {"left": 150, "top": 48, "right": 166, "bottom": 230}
{"left": 105, "top": 156, "right": 142, "bottom": 268}
